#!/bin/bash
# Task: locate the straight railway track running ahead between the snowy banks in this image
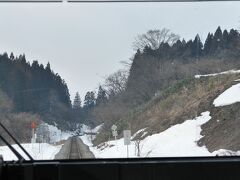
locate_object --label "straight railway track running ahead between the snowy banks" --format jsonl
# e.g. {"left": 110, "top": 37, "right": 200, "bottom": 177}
{"left": 68, "top": 137, "right": 82, "bottom": 159}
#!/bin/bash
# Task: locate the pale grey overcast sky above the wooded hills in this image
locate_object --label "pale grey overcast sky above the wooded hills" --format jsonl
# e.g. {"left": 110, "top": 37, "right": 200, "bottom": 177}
{"left": 0, "top": 2, "right": 240, "bottom": 99}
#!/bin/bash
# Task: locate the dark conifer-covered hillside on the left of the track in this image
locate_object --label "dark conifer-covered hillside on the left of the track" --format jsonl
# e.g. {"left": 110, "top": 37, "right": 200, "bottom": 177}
{"left": 0, "top": 53, "right": 73, "bottom": 128}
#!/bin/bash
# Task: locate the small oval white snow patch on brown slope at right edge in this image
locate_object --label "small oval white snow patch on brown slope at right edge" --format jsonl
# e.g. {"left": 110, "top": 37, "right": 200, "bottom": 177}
{"left": 213, "top": 83, "right": 240, "bottom": 107}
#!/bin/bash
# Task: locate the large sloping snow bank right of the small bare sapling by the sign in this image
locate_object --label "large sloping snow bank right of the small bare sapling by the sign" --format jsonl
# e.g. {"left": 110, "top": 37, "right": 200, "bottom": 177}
{"left": 142, "top": 112, "right": 211, "bottom": 157}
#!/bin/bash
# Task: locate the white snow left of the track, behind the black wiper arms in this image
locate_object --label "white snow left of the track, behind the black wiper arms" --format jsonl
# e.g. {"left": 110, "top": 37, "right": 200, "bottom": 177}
{"left": 0, "top": 143, "right": 62, "bottom": 161}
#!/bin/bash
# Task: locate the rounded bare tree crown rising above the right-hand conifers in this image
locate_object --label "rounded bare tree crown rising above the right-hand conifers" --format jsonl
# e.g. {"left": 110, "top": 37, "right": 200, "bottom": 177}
{"left": 133, "top": 28, "right": 180, "bottom": 51}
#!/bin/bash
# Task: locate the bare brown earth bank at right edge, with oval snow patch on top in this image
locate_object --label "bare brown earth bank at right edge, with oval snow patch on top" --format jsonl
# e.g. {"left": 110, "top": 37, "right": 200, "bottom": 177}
{"left": 199, "top": 81, "right": 240, "bottom": 152}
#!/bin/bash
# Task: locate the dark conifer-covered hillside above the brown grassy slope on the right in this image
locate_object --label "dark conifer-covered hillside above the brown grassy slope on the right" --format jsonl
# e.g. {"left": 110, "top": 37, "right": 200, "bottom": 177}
{"left": 126, "top": 27, "right": 240, "bottom": 104}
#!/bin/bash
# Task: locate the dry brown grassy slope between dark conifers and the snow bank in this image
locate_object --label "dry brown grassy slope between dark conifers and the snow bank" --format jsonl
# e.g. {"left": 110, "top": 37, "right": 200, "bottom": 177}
{"left": 122, "top": 74, "right": 240, "bottom": 134}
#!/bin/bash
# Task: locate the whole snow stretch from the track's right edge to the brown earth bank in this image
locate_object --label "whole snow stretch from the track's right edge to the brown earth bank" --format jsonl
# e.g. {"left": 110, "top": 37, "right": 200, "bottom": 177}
{"left": 80, "top": 111, "right": 218, "bottom": 158}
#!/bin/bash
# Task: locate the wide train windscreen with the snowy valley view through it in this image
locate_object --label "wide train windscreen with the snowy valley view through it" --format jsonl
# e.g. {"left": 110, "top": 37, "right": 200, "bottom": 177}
{"left": 0, "top": 0, "right": 240, "bottom": 161}
